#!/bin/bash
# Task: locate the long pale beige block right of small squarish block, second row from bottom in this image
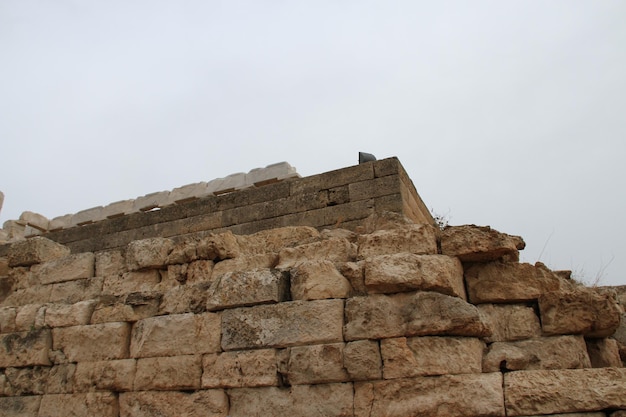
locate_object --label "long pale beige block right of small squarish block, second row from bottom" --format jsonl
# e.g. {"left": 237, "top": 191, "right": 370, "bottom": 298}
{"left": 380, "top": 336, "right": 484, "bottom": 379}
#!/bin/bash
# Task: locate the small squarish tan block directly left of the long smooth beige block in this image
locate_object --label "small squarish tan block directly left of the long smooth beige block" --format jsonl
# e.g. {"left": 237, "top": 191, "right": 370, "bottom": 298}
{"left": 343, "top": 340, "right": 382, "bottom": 381}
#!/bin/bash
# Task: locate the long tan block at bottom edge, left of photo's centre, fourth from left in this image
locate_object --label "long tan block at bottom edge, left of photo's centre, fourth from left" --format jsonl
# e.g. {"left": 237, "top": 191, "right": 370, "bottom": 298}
{"left": 228, "top": 384, "right": 354, "bottom": 417}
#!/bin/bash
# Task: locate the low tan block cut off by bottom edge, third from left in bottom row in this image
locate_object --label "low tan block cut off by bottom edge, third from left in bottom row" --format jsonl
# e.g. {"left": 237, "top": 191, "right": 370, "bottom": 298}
{"left": 119, "top": 389, "right": 228, "bottom": 417}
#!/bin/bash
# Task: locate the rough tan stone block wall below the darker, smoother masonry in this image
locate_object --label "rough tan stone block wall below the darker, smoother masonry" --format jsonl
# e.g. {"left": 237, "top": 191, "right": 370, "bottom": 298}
{"left": 0, "top": 158, "right": 626, "bottom": 417}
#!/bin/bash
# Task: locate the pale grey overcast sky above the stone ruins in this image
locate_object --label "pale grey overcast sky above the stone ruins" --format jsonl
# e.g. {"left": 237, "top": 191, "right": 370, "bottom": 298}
{"left": 0, "top": 0, "right": 626, "bottom": 285}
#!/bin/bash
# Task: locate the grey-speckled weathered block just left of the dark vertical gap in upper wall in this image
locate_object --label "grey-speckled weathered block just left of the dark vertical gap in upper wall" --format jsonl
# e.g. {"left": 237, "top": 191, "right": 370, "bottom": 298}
{"left": 206, "top": 268, "right": 289, "bottom": 311}
